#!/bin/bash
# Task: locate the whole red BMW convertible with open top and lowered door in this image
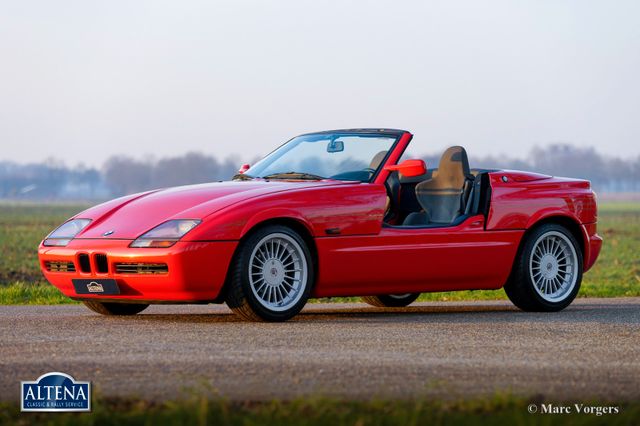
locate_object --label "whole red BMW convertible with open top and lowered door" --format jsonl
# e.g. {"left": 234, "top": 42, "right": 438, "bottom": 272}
{"left": 39, "top": 129, "right": 602, "bottom": 321}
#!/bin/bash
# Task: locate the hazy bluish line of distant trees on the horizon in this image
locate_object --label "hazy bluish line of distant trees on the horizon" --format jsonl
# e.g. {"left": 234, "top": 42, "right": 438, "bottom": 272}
{"left": 0, "top": 144, "right": 640, "bottom": 200}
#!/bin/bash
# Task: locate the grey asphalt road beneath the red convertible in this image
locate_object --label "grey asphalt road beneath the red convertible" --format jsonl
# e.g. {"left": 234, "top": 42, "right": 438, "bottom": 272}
{"left": 0, "top": 298, "right": 640, "bottom": 402}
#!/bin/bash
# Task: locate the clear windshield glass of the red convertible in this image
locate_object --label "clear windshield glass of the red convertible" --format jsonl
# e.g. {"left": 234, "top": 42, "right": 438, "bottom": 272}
{"left": 245, "top": 133, "right": 396, "bottom": 182}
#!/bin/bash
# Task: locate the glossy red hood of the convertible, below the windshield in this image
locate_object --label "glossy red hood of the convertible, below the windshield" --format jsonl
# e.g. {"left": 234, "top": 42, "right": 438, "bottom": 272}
{"left": 75, "top": 180, "right": 344, "bottom": 239}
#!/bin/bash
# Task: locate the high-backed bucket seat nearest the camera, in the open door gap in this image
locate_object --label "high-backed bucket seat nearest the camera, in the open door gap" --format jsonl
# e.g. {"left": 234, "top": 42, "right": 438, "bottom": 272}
{"left": 405, "top": 146, "right": 471, "bottom": 225}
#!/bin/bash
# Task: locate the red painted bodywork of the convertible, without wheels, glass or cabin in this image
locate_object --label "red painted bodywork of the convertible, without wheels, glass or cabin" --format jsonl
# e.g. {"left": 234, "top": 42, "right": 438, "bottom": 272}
{"left": 39, "top": 132, "right": 602, "bottom": 303}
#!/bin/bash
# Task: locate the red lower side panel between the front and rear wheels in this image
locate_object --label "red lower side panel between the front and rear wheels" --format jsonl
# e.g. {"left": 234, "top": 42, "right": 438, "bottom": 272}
{"left": 314, "top": 215, "right": 524, "bottom": 297}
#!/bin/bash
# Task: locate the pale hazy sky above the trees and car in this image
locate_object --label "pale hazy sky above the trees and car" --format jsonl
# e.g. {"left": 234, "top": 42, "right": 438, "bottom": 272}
{"left": 0, "top": 0, "right": 640, "bottom": 165}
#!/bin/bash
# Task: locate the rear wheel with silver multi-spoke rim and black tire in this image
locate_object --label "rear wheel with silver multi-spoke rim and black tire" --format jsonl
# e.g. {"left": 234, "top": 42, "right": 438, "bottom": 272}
{"left": 504, "top": 223, "right": 582, "bottom": 312}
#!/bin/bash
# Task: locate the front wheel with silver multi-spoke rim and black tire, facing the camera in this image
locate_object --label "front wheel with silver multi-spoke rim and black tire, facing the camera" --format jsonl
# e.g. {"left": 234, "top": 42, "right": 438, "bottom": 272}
{"left": 226, "top": 225, "right": 315, "bottom": 322}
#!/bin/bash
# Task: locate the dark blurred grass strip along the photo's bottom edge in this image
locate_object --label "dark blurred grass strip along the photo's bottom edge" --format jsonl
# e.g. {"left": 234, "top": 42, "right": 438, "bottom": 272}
{"left": 0, "top": 395, "right": 640, "bottom": 426}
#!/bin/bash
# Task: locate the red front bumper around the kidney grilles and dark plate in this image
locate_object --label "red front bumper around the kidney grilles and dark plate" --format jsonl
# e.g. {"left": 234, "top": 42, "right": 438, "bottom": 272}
{"left": 38, "top": 239, "right": 238, "bottom": 303}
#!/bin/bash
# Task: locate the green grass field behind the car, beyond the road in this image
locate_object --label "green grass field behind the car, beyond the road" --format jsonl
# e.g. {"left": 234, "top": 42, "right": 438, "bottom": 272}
{"left": 0, "top": 202, "right": 640, "bottom": 304}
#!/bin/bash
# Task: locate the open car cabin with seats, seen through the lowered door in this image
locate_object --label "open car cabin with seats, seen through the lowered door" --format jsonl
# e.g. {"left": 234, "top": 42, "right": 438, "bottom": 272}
{"left": 380, "top": 146, "right": 494, "bottom": 228}
